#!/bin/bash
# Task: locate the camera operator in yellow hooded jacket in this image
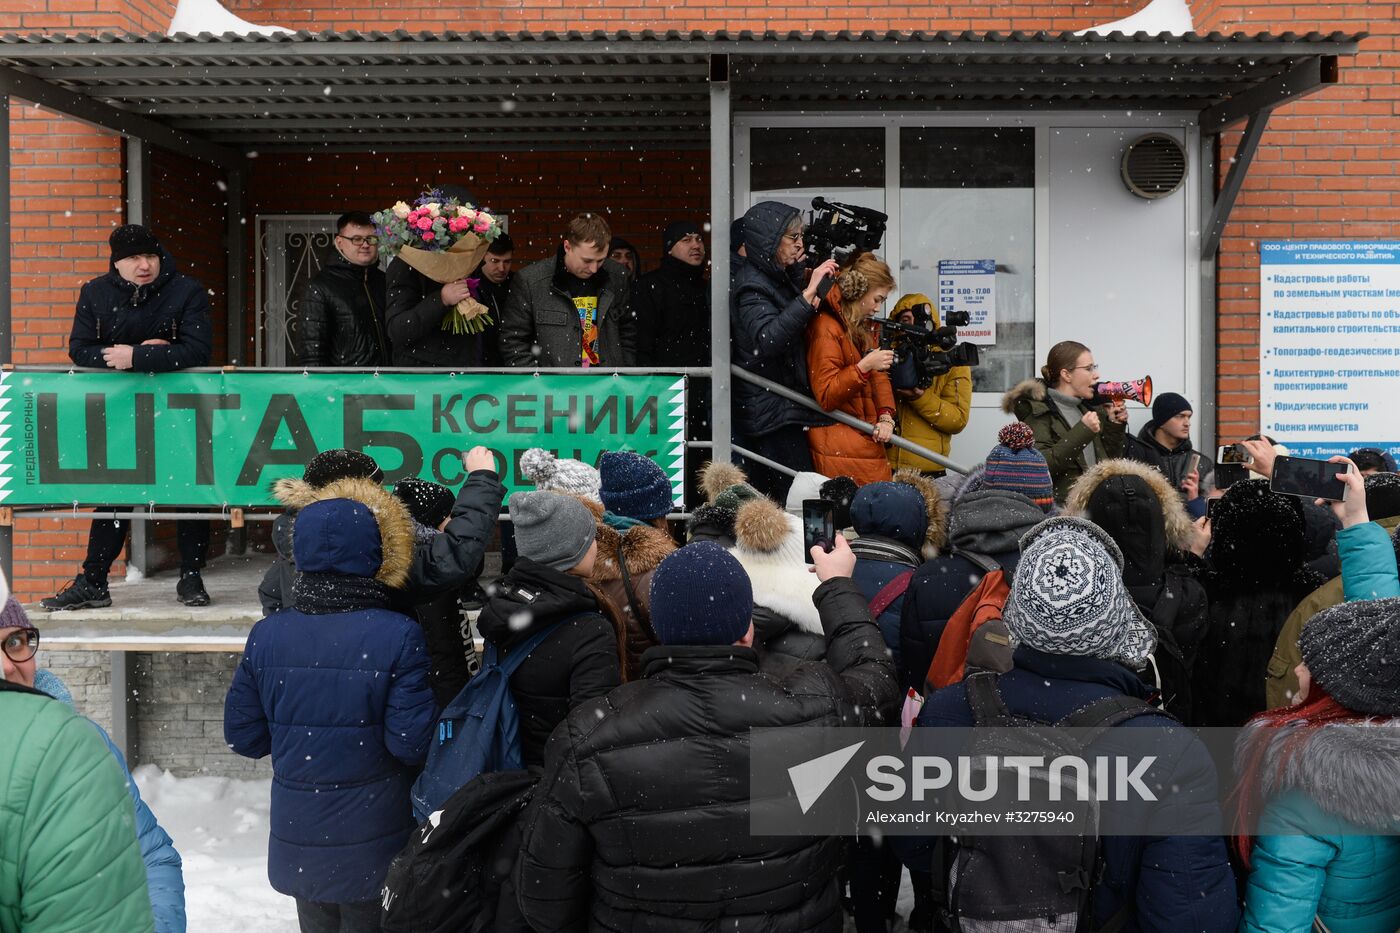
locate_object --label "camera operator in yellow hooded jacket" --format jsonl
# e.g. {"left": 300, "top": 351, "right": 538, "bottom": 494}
{"left": 889, "top": 293, "right": 972, "bottom": 479}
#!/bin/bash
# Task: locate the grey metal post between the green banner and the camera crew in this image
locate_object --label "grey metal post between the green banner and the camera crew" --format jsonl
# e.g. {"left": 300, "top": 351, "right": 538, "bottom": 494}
{"left": 710, "top": 55, "right": 734, "bottom": 461}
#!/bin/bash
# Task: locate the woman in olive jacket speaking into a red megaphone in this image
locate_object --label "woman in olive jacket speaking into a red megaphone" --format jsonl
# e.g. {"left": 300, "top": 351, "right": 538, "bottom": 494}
{"left": 1001, "top": 340, "right": 1128, "bottom": 503}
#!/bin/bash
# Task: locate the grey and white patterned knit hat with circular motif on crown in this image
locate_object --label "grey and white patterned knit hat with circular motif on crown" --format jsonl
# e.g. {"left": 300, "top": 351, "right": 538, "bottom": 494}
{"left": 1002, "top": 516, "right": 1156, "bottom": 670}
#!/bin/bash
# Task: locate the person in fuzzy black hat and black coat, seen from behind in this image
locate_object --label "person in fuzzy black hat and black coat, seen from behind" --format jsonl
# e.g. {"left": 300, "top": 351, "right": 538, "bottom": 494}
{"left": 1193, "top": 479, "right": 1324, "bottom": 727}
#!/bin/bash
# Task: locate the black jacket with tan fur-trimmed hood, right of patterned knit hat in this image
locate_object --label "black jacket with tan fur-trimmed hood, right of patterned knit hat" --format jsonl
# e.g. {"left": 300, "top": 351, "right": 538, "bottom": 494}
{"left": 1065, "top": 459, "right": 1210, "bottom": 726}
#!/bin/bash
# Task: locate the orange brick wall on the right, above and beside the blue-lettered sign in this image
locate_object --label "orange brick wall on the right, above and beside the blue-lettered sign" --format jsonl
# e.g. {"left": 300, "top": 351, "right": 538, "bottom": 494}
{"left": 1191, "top": 0, "right": 1400, "bottom": 443}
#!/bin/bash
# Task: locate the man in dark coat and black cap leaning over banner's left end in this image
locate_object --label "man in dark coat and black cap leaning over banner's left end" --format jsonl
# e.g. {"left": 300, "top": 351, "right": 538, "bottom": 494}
{"left": 41, "top": 224, "right": 210, "bottom": 611}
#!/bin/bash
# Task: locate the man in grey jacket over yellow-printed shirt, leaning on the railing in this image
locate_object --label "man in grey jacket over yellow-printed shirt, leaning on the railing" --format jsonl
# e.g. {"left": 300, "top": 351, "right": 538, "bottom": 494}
{"left": 501, "top": 214, "right": 637, "bottom": 368}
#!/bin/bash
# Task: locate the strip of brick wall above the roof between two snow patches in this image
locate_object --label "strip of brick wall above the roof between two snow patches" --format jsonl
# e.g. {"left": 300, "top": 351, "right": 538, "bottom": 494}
{"left": 225, "top": 0, "right": 1147, "bottom": 32}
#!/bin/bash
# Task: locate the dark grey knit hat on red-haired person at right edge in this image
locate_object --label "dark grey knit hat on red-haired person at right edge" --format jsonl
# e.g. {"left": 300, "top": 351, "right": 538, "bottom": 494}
{"left": 1298, "top": 598, "right": 1400, "bottom": 716}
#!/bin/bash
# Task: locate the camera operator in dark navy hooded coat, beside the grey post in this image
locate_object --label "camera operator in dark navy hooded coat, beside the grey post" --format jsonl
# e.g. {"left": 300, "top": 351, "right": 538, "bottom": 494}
{"left": 729, "top": 200, "right": 837, "bottom": 502}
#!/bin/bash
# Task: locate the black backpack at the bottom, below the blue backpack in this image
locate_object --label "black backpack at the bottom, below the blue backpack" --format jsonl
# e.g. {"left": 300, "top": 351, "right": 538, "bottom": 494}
{"left": 381, "top": 770, "right": 535, "bottom": 933}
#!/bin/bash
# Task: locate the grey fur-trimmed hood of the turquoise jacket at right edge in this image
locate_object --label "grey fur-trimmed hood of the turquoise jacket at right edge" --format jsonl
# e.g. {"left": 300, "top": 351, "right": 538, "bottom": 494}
{"left": 1235, "top": 719, "right": 1400, "bottom": 832}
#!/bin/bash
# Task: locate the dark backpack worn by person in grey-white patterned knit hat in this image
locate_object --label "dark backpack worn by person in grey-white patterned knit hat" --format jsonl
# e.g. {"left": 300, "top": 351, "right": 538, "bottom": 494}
{"left": 945, "top": 672, "right": 1162, "bottom": 933}
